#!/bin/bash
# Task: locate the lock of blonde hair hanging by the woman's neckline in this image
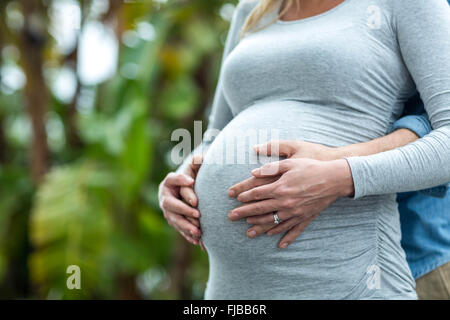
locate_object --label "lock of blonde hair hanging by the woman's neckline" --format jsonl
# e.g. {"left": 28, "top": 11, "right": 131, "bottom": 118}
{"left": 241, "top": 0, "right": 300, "bottom": 38}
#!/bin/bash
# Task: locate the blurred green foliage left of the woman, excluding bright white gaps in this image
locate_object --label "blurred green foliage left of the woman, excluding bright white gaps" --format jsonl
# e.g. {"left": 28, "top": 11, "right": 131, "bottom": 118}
{"left": 0, "top": 0, "right": 236, "bottom": 299}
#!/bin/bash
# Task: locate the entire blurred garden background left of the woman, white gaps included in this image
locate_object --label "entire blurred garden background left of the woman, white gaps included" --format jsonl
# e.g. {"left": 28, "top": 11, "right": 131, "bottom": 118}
{"left": 0, "top": 0, "right": 237, "bottom": 299}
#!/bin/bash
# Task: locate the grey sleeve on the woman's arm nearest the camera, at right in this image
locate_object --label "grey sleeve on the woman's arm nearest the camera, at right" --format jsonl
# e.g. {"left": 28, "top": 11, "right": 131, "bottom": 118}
{"left": 347, "top": 0, "right": 450, "bottom": 198}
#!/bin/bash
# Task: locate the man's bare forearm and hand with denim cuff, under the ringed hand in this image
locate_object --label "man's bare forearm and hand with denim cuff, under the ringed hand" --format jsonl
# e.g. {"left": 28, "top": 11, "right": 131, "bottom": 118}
{"left": 229, "top": 114, "right": 431, "bottom": 248}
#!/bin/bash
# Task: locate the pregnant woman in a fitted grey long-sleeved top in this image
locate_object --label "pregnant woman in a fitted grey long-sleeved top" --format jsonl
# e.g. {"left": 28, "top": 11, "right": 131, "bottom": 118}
{"left": 160, "top": 0, "right": 450, "bottom": 299}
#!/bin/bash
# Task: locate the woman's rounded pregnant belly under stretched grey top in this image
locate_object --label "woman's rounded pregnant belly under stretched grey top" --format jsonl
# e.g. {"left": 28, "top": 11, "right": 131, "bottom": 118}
{"left": 195, "top": 101, "right": 408, "bottom": 299}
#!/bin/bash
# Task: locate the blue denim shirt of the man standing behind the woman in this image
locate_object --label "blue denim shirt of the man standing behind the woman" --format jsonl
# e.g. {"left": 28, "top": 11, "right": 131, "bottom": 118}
{"left": 393, "top": 95, "right": 450, "bottom": 279}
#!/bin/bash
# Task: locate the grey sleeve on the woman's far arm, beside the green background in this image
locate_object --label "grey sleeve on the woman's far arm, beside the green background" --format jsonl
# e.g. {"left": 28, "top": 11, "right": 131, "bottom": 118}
{"left": 177, "top": 1, "right": 254, "bottom": 172}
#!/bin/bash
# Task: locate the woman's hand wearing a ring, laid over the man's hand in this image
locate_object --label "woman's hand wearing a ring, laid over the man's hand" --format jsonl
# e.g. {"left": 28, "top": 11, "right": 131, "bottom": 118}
{"left": 229, "top": 156, "right": 353, "bottom": 248}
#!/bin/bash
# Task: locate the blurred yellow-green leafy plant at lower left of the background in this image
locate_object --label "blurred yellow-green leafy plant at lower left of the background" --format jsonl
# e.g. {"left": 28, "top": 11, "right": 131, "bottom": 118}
{"left": 30, "top": 163, "right": 113, "bottom": 297}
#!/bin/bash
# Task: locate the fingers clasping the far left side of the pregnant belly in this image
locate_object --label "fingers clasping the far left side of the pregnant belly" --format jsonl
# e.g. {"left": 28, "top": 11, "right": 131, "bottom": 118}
{"left": 158, "top": 156, "right": 204, "bottom": 249}
